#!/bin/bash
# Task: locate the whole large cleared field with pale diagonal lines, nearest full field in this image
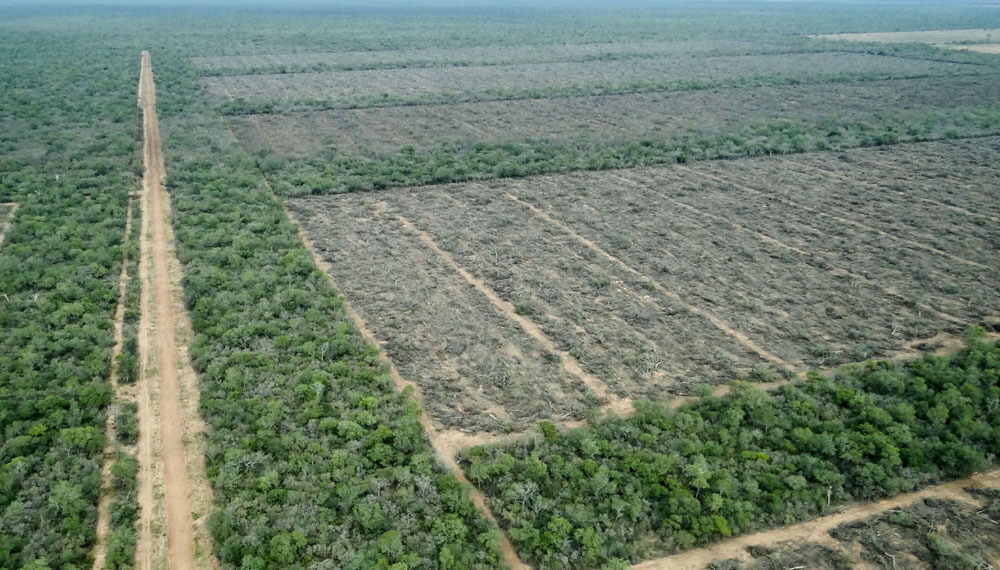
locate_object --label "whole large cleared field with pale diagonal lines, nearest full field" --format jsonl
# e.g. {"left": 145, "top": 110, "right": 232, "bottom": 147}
{"left": 291, "top": 138, "right": 1000, "bottom": 429}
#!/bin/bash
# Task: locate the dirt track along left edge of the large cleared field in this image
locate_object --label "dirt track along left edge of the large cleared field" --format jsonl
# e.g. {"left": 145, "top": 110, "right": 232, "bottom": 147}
{"left": 282, "top": 202, "right": 529, "bottom": 570}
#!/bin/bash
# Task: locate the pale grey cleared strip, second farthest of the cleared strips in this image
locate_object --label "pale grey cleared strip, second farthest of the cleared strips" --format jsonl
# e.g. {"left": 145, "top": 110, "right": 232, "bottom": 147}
{"left": 202, "top": 53, "right": 970, "bottom": 105}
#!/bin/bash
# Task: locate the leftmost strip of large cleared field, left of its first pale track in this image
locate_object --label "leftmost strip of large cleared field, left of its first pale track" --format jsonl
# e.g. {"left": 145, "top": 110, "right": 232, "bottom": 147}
{"left": 284, "top": 195, "right": 596, "bottom": 430}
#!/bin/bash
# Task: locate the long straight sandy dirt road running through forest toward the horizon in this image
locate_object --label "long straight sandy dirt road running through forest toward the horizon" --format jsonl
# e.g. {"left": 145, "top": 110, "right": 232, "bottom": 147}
{"left": 137, "top": 51, "right": 213, "bottom": 570}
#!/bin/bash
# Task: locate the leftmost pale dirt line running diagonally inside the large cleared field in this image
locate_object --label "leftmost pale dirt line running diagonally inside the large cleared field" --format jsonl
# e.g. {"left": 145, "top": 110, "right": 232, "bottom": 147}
{"left": 395, "top": 214, "right": 631, "bottom": 406}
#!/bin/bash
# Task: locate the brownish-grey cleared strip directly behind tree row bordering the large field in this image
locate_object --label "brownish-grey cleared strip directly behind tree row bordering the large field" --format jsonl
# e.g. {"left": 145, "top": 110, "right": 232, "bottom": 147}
{"left": 228, "top": 76, "right": 1000, "bottom": 157}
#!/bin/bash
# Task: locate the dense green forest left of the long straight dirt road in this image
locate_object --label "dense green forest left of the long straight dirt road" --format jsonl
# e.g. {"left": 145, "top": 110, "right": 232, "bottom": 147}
{"left": 0, "top": 25, "right": 141, "bottom": 568}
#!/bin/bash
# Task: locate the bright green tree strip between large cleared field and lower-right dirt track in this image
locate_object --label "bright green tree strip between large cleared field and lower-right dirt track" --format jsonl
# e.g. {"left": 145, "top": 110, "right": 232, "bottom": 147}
{"left": 462, "top": 328, "right": 1000, "bottom": 568}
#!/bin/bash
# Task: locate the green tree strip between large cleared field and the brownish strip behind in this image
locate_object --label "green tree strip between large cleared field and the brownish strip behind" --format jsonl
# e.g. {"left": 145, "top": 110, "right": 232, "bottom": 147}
{"left": 258, "top": 99, "right": 1000, "bottom": 196}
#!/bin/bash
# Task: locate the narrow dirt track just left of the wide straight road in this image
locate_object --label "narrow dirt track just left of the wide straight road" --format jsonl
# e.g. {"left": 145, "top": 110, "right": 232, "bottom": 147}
{"left": 91, "top": 198, "right": 136, "bottom": 570}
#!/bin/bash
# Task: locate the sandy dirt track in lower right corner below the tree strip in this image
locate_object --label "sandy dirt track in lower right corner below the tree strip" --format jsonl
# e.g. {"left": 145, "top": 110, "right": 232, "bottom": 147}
{"left": 631, "top": 469, "right": 1000, "bottom": 570}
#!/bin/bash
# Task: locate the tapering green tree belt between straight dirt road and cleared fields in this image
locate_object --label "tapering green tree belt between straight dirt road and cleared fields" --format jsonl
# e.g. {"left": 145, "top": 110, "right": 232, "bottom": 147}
{"left": 154, "top": 54, "right": 502, "bottom": 570}
